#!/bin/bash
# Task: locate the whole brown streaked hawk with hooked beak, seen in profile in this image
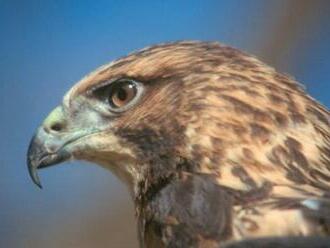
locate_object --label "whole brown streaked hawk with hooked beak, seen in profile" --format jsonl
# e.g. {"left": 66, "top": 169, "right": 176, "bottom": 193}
{"left": 28, "top": 41, "right": 330, "bottom": 248}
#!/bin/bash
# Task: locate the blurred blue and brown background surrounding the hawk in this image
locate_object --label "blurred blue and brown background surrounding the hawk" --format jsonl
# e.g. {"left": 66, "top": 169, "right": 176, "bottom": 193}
{"left": 0, "top": 0, "right": 330, "bottom": 248}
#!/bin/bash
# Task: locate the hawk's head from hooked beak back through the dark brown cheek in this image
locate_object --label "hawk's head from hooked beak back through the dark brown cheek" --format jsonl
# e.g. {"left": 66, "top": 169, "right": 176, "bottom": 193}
{"left": 28, "top": 42, "right": 218, "bottom": 190}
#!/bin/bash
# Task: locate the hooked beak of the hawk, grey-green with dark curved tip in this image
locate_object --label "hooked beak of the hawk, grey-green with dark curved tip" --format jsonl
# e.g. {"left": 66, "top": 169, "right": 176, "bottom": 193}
{"left": 27, "top": 106, "right": 100, "bottom": 188}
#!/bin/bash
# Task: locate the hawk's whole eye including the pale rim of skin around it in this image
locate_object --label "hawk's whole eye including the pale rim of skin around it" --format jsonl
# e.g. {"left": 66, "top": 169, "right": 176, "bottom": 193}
{"left": 107, "top": 79, "right": 143, "bottom": 113}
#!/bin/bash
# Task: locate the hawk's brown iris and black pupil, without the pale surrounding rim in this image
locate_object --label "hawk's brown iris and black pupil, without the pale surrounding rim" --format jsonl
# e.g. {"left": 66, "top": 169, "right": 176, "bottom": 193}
{"left": 109, "top": 81, "right": 137, "bottom": 108}
